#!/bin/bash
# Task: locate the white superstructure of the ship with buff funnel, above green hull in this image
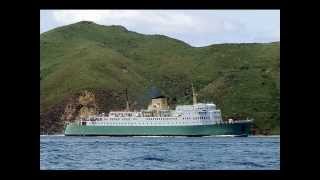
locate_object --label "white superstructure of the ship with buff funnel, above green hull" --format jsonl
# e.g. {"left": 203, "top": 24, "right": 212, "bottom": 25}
{"left": 81, "top": 87, "right": 223, "bottom": 126}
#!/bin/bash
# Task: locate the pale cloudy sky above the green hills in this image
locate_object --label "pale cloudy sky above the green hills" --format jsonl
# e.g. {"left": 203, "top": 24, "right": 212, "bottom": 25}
{"left": 40, "top": 10, "right": 280, "bottom": 47}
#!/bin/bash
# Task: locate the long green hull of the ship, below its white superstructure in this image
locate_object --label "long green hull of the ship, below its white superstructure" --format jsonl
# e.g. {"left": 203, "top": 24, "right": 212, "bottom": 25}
{"left": 65, "top": 123, "right": 251, "bottom": 136}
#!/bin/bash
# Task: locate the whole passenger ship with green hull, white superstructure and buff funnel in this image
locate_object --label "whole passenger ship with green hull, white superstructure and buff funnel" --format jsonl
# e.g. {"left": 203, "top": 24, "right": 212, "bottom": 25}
{"left": 64, "top": 85, "right": 253, "bottom": 137}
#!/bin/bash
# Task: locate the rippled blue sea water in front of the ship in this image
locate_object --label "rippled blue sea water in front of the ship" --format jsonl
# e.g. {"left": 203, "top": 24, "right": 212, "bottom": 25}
{"left": 40, "top": 136, "right": 280, "bottom": 170}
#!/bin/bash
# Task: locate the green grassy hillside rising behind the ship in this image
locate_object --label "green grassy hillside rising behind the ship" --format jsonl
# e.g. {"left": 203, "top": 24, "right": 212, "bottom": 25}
{"left": 40, "top": 21, "right": 280, "bottom": 133}
